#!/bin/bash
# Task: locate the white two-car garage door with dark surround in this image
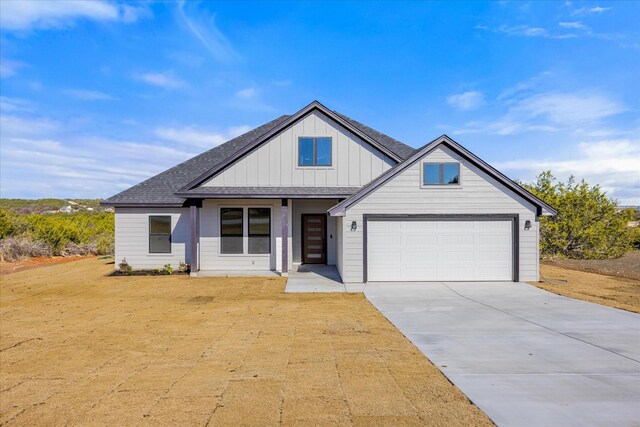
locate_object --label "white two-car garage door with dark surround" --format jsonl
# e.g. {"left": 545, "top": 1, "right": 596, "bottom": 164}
{"left": 367, "top": 220, "right": 513, "bottom": 281}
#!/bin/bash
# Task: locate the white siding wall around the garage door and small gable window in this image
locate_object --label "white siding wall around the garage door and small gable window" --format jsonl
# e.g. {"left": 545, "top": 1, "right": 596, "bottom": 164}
{"left": 341, "top": 147, "right": 539, "bottom": 282}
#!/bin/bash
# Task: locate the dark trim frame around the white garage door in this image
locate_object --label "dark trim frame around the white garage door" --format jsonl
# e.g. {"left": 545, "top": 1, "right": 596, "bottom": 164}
{"left": 362, "top": 214, "right": 520, "bottom": 283}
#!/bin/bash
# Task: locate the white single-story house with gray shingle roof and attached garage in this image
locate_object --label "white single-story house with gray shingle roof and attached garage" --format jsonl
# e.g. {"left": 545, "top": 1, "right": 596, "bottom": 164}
{"left": 103, "top": 102, "right": 555, "bottom": 282}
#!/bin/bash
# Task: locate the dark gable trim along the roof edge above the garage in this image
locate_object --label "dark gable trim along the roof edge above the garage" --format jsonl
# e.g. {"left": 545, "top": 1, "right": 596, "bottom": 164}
{"left": 329, "top": 135, "right": 557, "bottom": 216}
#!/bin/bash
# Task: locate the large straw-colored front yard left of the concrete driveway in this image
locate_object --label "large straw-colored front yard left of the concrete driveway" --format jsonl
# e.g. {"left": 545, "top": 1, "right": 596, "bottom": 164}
{"left": 0, "top": 259, "right": 491, "bottom": 426}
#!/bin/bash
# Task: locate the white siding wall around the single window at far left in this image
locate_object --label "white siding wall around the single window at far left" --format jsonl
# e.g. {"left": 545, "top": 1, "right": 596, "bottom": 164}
{"left": 115, "top": 208, "right": 191, "bottom": 270}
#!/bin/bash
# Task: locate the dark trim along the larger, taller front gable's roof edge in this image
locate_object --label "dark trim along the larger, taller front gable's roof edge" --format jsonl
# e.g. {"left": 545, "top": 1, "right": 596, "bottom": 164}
{"left": 176, "top": 101, "right": 403, "bottom": 195}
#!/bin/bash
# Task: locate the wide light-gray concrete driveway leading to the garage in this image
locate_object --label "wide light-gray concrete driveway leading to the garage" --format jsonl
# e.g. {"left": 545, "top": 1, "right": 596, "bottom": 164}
{"left": 365, "top": 283, "right": 640, "bottom": 426}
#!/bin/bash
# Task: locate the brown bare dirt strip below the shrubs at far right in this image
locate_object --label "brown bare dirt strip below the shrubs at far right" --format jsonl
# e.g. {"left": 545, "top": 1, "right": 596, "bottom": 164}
{"left": 543, "top": 251, "right": 640, "bottom": 280}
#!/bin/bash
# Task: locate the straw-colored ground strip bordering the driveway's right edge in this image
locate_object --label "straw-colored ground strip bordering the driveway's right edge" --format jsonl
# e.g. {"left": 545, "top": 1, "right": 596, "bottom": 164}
{"left": 531, "top": 264, "right": 640, "bottom": 313}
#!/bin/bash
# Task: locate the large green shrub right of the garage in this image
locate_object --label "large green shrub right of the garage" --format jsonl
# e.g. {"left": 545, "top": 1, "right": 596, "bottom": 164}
{"left": 523, "top": 171, "right": 633, "bottom": 259}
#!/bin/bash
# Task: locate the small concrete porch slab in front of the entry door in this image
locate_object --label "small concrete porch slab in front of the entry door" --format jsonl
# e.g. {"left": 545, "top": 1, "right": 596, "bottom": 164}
{"left": 284, "top": 264, "right": 347, "bottom": 293}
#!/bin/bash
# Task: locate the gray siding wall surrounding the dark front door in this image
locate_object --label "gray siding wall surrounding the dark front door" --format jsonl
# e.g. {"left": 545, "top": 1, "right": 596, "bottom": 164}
{"left": 290, "top": 199, "right": 338, "bottom": 265}
